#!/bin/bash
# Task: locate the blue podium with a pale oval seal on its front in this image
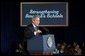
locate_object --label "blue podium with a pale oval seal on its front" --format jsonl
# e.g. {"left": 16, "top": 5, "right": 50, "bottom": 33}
{"left": 27, "top": 34, "right": 56, "bottom": 53}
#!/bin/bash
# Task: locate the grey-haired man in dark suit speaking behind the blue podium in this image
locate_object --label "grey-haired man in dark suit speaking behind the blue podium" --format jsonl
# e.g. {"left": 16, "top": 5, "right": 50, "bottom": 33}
{"left": 25, "top": 16, "right": 42, "bottom": 39}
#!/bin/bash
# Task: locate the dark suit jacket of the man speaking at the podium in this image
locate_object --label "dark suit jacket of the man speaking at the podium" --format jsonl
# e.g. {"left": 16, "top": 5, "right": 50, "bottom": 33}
{"left": 24, "top": 24, "right": 35, "bottom": 39}
